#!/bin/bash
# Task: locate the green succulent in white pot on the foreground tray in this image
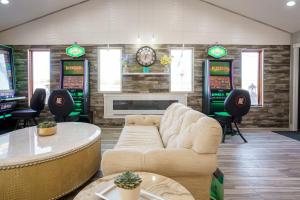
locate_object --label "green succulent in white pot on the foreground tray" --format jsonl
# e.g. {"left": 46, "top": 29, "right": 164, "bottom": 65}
{"left": 114, "top": 172, "right": 142, "bottom": 200}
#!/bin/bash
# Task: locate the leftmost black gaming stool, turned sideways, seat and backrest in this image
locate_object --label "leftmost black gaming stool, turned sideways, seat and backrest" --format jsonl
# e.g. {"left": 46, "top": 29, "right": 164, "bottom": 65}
{"left": 11, "top": 88, "right": 46, "bottom": 128}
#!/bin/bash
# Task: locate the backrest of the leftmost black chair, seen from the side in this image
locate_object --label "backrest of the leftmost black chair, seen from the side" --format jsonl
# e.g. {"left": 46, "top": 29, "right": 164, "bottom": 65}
{"left": 30, "top": 88, "right": 46, "bottom": 113}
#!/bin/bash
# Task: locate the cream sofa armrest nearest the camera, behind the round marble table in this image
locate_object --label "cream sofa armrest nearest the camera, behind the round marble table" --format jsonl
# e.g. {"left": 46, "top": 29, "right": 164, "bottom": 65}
{"left": 101, "top": 149, "right": 217, "bottom": 177}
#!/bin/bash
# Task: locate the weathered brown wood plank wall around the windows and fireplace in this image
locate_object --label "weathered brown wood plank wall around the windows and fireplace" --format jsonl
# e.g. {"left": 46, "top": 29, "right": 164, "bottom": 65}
{"left": 14, "top": 44, "right": 290, "bottom": 128}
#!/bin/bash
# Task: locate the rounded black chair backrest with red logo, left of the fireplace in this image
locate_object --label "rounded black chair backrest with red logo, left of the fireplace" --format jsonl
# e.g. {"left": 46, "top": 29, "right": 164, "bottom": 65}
{"left": 48, "top": 89, "right": 74, "bottom": 121}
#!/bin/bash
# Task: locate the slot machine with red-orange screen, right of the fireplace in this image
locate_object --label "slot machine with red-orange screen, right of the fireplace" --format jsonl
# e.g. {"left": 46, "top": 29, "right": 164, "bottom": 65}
{"left": 202, "top": 60, "right": 233, "bottom": 116}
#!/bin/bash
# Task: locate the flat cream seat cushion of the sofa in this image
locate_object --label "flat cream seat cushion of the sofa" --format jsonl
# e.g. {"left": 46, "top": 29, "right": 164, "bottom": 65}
{"left": 115, "top": 126, "right": 164, "bottom": 152}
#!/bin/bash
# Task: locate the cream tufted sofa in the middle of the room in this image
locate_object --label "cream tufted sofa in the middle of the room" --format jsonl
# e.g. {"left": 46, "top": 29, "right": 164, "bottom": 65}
{"left": 101, "top": 103, "right": 222, "bottom": 200}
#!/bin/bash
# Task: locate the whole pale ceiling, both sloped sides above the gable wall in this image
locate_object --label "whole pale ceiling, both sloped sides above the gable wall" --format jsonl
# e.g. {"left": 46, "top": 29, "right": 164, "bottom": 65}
{"left": 0, "top": 0, "right": 300, "bottom": 33}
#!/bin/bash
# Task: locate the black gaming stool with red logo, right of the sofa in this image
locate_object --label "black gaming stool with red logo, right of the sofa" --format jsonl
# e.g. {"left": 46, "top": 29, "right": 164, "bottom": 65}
{"left": 215, "top": 89, "right": 251, "bottom": 142}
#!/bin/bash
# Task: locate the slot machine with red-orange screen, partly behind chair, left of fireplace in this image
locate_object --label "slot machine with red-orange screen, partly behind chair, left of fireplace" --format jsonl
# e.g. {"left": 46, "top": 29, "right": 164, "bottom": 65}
{"left": 60, "top": 59, "right": 90, "bottom": 122}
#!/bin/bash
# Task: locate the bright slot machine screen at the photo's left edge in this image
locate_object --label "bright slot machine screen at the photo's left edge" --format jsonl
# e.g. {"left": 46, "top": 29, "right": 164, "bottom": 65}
{"left": 0, "top": 48, "right": 13, "bottom": 91}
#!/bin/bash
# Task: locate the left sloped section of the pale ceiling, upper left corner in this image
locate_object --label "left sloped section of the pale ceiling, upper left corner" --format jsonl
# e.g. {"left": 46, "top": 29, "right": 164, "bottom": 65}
{"left": 0, "top": 0, "right": 83, "bottom": 31}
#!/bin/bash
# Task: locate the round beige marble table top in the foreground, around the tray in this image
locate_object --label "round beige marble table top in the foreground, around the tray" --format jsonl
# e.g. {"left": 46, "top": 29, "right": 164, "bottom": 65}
{"left": 74, "top": 172, "right": 194, "bottom": 200}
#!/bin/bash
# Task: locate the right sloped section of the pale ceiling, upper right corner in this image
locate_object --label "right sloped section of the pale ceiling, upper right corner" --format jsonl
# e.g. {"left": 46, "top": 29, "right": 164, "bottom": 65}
{"left": 206, "top": 0, "right": 300, "bottom": 33}
